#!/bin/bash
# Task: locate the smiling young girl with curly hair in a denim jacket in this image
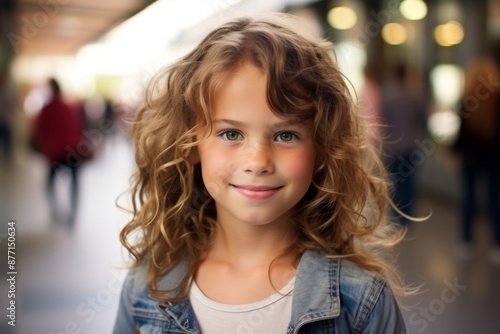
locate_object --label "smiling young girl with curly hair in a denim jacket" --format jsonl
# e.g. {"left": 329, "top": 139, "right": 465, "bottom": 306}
{"left": 114, "top": 14, "right": 405, "bottom": 334}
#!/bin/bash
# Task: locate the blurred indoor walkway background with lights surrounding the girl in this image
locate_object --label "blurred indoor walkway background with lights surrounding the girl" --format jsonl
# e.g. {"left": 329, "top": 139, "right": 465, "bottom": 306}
{"left": 0, "top": 0, "right": 500, "bottom": 334}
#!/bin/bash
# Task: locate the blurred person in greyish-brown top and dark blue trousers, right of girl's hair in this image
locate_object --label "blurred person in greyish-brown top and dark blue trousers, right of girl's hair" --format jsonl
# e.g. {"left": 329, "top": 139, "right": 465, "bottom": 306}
{"left": 380, "top": 64, "right": 426, "bottom": 225}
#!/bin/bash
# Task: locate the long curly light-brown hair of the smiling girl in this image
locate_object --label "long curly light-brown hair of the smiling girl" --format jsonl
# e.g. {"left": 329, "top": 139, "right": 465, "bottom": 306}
{"left": 120, "top": 13, "right": 403, "bottom": 301}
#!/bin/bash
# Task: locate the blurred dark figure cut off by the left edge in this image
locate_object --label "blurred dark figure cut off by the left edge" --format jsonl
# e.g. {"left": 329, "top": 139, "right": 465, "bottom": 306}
{"left": 0, "top": 74, "right": 15, "bottom": 162}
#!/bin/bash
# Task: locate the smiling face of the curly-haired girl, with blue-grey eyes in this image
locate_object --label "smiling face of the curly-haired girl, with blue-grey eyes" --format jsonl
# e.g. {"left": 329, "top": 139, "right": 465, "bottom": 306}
{"left": 198, "top": 62, "right": 315, "bottom": 225}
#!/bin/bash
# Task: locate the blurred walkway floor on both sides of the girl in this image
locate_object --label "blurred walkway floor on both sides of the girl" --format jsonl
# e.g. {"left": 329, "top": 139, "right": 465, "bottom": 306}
{"left": 0, "top": 129, "right": 500, "bottom": 334}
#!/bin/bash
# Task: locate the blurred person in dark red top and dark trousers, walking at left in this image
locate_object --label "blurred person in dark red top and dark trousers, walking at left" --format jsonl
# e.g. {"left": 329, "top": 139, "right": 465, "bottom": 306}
{"left": 32, "top": 78, "right": 85, "bottom": 227}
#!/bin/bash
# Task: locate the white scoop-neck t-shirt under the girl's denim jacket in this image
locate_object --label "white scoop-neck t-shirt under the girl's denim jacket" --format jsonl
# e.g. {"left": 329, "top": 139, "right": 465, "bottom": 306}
{"left": 189, "top": 277, "right": 295, "bottom": 334}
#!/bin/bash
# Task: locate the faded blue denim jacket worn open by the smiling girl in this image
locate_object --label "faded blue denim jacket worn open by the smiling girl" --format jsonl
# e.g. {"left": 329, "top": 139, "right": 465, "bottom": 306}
{"left": 113, "top": 251, "right": 406, "bottom": 334}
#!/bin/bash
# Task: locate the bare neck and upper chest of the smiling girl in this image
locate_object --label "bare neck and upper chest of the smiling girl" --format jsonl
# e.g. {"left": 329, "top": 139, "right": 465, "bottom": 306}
{"left": 194, "top": 215, "right": 297, "bottom": 304}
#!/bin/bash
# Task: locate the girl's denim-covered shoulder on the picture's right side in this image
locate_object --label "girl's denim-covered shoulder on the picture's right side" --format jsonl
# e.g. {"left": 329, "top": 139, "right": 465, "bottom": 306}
{"left": 292, "top": 251, "right": 404, "bottom": 333}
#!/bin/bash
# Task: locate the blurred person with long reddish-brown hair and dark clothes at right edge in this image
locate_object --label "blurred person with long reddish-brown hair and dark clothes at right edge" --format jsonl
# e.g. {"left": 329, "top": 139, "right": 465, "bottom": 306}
{"left": 454, "top": 57, "right": 500, "bottom": 265}
